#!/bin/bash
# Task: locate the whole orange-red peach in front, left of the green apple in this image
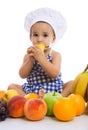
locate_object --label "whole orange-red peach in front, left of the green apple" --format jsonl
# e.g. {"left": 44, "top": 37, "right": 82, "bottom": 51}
{"left": 24, "top": 98, "right": 47, "bottom": 121}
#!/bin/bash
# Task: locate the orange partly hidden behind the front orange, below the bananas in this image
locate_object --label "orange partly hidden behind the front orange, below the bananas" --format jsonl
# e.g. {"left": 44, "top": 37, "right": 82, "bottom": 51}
{"left": 68, "top": 94, "right": 86, "bottom": 116}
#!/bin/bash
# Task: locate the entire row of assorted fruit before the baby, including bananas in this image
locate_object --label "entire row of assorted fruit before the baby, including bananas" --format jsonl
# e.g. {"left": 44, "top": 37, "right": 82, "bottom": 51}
{"left": 0, "top": 65, "right": 88, "bottom": 121}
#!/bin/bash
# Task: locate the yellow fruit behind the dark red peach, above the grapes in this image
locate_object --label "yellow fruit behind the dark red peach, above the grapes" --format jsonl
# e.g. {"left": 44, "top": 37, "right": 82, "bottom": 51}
{"left": 3, "top": 89, "right": 19, "bottom": 102}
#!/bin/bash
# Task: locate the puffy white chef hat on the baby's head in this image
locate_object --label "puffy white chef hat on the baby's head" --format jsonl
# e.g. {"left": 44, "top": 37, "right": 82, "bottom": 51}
{"left": 24, "top": 7, "right": 67, "bottom": 41}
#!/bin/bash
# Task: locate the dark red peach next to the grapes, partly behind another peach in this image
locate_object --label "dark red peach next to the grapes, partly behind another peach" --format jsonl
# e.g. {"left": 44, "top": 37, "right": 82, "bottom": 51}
{"left": 7, "top": 95, "right": 26, "bottom": 117}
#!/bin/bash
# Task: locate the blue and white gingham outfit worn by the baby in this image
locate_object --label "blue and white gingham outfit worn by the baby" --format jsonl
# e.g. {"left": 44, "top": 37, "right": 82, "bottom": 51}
{"left": 22, "top": 54, "right": 63, "bottom": 94}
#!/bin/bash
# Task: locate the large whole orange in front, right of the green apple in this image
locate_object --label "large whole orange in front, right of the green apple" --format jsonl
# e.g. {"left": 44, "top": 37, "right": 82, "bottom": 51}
{"left": 53, "top": 97, "right": 76, "bottom": 121}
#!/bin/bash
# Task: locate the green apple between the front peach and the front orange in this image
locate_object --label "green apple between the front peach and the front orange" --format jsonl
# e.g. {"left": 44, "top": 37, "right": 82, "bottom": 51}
{"left": 43, "top": 92, "right": 62, "bottom": 116}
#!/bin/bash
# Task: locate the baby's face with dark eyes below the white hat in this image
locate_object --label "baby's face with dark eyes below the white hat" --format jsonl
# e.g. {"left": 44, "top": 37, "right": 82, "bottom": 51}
{"left": 30, "top": 22, "right": 55, "bottom": 47}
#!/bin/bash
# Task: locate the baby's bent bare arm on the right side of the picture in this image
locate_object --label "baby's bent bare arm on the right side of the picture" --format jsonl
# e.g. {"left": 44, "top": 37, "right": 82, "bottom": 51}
{"left": 39, "top": 51, "right": 61, "bottom": 78}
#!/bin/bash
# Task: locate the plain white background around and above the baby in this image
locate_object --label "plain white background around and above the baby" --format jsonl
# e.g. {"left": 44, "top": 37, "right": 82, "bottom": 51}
{"left": 0, "top": 0, "right": 88, "bottom": 89}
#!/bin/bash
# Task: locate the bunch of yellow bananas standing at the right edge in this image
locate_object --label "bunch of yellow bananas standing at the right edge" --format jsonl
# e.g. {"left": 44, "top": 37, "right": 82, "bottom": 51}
{"left": 72, "top": 65, "right": 88, "bottom": 100}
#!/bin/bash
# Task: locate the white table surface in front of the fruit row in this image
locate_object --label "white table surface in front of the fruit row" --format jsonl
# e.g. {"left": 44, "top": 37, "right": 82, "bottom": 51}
{"left": 0, "top": 114, "right": 88, "bottom": 130}
